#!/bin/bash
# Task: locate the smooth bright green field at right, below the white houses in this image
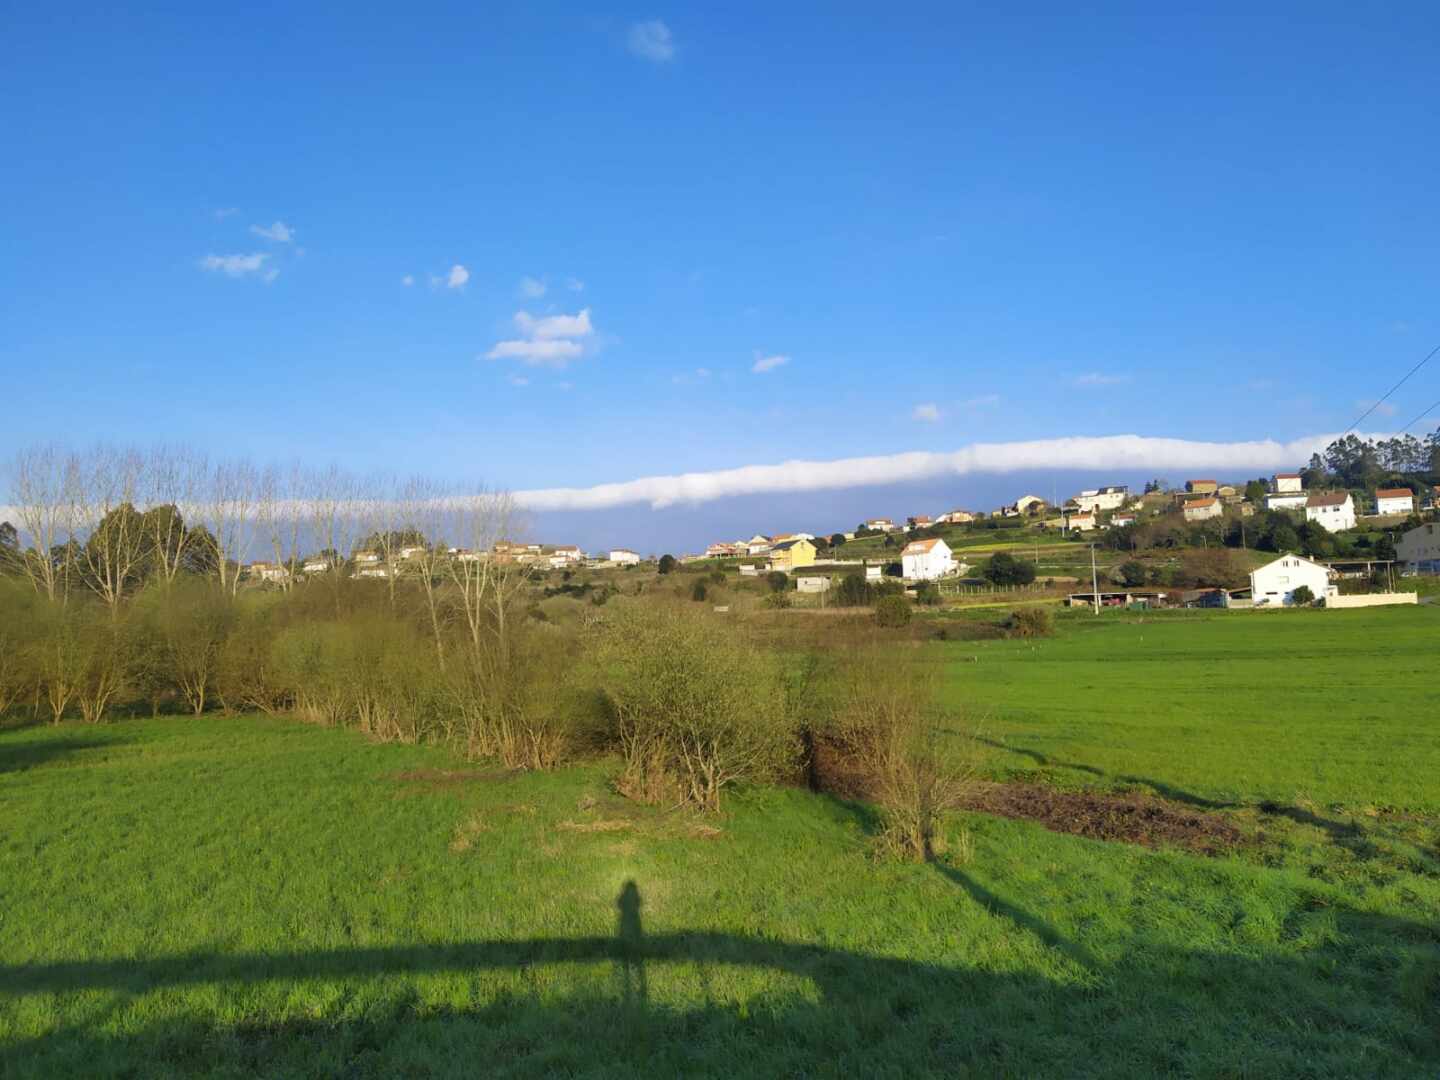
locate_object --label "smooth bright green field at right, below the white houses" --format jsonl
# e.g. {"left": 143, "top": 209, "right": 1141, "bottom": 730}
{"left": 949, "top": 606, "right": 1440, "bottom": 814}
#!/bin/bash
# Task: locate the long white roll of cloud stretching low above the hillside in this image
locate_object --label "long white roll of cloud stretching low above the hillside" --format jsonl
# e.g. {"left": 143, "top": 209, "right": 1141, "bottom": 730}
{"left": 514, "top": 435, "right": 1335, "bottom": 511}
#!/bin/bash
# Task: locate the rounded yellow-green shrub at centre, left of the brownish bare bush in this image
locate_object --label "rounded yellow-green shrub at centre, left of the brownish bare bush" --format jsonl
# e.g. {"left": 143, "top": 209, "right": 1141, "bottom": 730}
{"left": 598, "top": 608, "right": 798, "bottom": 811}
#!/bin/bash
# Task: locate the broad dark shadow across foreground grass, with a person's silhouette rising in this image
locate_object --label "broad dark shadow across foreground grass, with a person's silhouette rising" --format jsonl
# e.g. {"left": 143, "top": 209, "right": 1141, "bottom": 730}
{"left": 0, "top": 881, "right": 1440, "bottom": 1077}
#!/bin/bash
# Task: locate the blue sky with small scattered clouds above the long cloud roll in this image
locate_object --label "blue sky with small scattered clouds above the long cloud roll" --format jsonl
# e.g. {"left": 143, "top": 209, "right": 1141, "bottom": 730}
{"left": 0, "top": 4, "right": 1440, "bottom": 550}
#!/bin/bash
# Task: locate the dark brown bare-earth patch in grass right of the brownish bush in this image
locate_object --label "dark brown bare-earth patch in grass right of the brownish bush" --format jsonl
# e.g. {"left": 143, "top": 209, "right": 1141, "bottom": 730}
{"left": 965, "top": 783, "right": 1244, "bottom": 855}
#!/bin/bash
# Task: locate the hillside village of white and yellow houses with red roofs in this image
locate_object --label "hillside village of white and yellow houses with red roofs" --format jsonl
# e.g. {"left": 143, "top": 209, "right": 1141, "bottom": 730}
{"left": 245, "top": 462, "right": 1440, "bottom": 608}
